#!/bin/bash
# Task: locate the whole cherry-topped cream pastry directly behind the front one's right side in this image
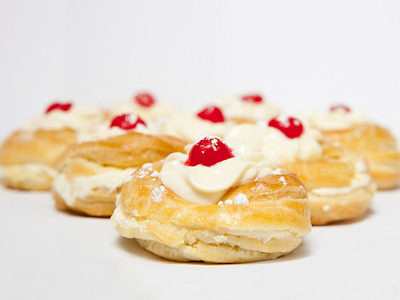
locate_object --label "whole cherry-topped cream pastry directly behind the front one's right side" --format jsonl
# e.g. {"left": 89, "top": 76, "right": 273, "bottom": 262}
{"left": 225, "top": 117, "right": 375, "bottom": 225}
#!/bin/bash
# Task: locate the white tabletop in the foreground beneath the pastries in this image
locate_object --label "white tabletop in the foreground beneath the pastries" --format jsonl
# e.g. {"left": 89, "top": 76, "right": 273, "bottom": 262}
{"left": 0, "top": 189, "right": 400, "bottom": 299}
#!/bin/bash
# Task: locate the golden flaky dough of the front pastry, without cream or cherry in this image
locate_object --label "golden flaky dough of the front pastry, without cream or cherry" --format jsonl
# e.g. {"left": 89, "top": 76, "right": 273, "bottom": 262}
{"left": 112, "top": 162, "right": 311, "bottom": 263}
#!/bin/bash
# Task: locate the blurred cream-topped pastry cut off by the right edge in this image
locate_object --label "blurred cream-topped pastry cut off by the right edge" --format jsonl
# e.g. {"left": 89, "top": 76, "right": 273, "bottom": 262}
{"left": 305, "top": 105, "right": 400, "bottom": 190}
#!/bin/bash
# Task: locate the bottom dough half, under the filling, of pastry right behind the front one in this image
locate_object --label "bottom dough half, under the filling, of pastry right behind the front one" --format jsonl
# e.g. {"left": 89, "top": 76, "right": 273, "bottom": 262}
{"left": 309, "top": 183, "right": 376, "bottom": 225}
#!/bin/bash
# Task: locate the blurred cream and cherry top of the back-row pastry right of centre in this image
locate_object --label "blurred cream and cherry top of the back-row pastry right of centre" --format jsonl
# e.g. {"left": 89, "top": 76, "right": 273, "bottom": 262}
{"left": 216, "top": 94, "right": 281, "bottom": 123}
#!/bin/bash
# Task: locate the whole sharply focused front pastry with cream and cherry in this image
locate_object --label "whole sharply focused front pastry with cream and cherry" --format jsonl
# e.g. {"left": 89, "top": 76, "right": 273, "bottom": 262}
{"left": 112, "top": 136, "right": 311, "bottom": 263}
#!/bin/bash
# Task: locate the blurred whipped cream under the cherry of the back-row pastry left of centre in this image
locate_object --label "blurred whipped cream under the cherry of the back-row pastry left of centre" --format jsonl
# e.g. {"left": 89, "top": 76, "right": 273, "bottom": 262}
{"left": 110, "top": 100, "right": 175, "bottom": 121}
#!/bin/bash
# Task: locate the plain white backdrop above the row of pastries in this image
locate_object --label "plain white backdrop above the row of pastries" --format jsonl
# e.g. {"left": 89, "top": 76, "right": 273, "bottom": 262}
{"left": 0, "top": 0, "right": 400, "bottom": 136}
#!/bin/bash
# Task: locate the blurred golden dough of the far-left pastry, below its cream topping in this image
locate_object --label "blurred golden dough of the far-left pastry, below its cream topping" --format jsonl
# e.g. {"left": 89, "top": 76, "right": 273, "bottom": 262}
{"left": 0, "top": 129, "right": 76, "bottom": 190}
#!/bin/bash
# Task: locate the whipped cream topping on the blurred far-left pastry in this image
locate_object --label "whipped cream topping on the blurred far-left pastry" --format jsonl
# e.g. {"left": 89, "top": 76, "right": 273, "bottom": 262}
{"left": 22, "top": 106, "right": 104, "bottom": 131}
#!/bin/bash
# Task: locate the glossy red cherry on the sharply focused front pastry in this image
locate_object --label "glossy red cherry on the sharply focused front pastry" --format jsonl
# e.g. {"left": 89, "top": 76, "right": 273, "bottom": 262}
{"left": 185, "top": 136, "right": 234, "bottom": 167}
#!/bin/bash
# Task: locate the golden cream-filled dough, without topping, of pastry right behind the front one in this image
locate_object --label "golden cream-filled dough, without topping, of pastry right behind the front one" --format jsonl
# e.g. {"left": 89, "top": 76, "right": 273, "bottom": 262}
{"left": 281, "top": 143, "right": 375, "bottom": 225}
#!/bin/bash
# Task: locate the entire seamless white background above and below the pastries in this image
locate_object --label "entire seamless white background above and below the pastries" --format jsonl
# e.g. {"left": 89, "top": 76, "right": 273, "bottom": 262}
{"left": 0, "top": 0, "right": 400, "bottom": 299}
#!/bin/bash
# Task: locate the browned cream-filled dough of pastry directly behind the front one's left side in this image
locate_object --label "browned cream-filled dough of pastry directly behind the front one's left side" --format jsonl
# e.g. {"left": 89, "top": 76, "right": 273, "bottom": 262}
{"left": 53, "top": 132, "right": 185, "bottom": 216}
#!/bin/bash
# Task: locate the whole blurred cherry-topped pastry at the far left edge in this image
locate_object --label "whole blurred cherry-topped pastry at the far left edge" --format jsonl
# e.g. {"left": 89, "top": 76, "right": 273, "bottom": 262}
{"left": 0, "top": 102, "right": 103, "bottom": 190}
